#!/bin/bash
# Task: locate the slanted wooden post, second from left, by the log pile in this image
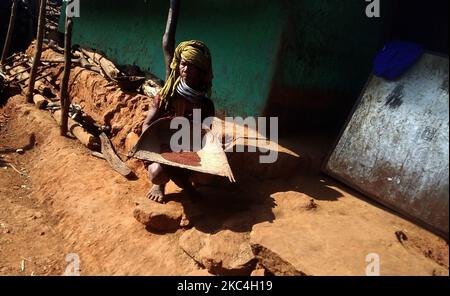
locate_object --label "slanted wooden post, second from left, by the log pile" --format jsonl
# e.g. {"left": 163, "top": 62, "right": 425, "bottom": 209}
{"left": 27, "top": 0, "right": 47, "bottom": 103}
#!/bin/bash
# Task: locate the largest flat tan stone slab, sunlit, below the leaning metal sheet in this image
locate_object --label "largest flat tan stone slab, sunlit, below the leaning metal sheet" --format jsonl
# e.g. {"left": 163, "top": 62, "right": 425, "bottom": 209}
{"left": 250, "top": 212, "right": 448, "bottom": 275}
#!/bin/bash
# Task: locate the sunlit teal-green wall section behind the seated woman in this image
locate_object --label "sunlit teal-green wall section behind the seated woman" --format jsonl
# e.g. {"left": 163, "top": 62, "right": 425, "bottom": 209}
{"left": 65, "top": 0, "right": 283, "bottom": 116}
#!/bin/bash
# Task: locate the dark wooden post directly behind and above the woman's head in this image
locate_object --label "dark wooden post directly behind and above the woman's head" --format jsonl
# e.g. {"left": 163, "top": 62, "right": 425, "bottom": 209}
{"left": 162, "top": 0, "right": 181, "bottom": 81}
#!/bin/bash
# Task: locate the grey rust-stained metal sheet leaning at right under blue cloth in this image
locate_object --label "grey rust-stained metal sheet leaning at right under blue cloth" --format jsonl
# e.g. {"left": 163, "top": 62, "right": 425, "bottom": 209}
{"left": 324, "top": 53, "right": 449, "bottom": 237}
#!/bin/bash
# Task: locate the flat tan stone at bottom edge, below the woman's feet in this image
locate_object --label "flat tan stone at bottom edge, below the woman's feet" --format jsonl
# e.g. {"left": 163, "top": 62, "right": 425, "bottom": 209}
{"left": 179, "top": 228, "right": 256, "bottom": 275}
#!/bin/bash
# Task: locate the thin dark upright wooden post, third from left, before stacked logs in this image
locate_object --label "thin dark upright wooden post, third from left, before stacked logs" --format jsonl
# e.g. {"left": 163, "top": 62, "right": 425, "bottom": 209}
{"left": 60, "top": 5, "right": 73, "bottom": 136}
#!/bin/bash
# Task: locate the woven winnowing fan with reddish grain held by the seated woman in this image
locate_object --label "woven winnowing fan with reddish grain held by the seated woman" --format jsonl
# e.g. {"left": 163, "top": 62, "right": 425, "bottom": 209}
{"left": 128, "top": 118, "right": 236, "bottom": 182}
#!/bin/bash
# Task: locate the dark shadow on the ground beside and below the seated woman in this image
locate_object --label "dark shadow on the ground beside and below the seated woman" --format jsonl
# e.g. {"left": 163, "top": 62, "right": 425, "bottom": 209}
{"left": 155, "top": 133, "right": 343, "bottom": 234}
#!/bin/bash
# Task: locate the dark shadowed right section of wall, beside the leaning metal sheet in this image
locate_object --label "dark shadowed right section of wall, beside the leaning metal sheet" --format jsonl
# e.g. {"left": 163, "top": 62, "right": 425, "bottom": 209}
{"left": 263, "top": 0, "right": 390, "bottom": 131}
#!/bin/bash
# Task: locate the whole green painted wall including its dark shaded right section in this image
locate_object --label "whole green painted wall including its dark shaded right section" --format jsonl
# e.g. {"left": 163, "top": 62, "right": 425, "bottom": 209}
{"left": 63, "top": 0, "right": 388, "bottom": 117}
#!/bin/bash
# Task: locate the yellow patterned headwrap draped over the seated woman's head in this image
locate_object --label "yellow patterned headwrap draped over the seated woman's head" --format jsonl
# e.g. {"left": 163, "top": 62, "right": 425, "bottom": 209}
{"left": 159, "top": 40, "right": 213, "bottom": 109}
